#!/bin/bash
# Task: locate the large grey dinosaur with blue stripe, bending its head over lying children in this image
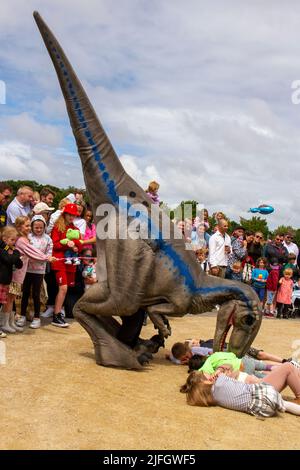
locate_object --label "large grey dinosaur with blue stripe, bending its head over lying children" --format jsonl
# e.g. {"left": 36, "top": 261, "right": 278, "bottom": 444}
{"left": 34, "top": 12, "right": 262, "bottom": 369}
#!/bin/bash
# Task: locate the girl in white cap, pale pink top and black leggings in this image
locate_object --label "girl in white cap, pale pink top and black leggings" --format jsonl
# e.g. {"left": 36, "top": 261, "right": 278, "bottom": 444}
{"left": 21, "top": 215, "right": 53, "bottom": 329}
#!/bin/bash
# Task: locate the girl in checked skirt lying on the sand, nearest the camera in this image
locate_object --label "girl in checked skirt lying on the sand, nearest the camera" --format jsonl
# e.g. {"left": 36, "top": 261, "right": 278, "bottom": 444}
{"left": 180, "top": 363, "right": 300, "bottom": 417}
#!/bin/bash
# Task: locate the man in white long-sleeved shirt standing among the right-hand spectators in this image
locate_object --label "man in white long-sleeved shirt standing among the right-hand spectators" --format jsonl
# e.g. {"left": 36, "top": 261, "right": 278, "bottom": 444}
{"left": 209, "top": 219, "right": 231, "bottom": 278}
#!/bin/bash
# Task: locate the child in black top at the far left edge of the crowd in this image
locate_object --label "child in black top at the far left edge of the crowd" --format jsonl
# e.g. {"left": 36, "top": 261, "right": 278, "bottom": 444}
{"left": 0, "top": 227, "right": 23, "bottom": 338}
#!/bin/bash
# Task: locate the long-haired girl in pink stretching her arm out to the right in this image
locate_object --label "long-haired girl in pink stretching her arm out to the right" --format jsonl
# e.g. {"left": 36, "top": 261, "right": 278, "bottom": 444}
{"left": 4, "top": 216, "right": 52, "bottom": 333}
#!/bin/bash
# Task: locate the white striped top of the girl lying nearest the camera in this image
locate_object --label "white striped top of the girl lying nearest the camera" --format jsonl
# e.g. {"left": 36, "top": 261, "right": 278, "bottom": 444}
{"left": 212, "top": 374, "right": 253, "bottom": 413}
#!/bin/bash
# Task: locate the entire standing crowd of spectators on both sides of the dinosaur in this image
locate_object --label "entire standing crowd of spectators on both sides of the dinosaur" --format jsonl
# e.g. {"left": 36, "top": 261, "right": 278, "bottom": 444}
{"left": 0, "top": 181, "right": 300, "bottom": 337}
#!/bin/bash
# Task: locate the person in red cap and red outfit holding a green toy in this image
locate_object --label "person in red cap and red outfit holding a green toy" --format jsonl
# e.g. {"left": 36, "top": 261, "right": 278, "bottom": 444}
{"left": 51, "top": 204, "right": 82, "bottom": 328}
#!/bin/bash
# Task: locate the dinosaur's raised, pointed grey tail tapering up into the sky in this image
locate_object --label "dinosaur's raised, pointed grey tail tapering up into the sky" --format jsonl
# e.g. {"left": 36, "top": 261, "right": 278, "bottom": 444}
{"left": 33, "top": 12, "right": 147, "bottom": 209}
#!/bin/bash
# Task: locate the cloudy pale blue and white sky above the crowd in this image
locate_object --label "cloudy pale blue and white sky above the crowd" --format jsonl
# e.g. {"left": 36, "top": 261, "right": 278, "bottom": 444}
{"left": 0, "top": 0, "right": 300, "bottom": 227}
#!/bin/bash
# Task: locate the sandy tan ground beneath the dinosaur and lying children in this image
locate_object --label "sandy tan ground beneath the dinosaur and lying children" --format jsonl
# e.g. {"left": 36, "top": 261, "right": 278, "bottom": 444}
{"left": 0, "top": 315, "right": 300, "bottom": 450}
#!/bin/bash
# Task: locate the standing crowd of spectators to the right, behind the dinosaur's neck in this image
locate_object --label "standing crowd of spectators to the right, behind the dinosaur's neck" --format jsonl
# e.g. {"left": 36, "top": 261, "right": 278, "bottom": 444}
{"left": 177, "top": 209, "right": 300, "bottom": 318}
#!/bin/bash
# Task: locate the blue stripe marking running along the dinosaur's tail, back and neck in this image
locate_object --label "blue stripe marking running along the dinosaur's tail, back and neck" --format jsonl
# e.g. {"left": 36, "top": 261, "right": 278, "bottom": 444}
{"left": 52, "top": 47, "right": 249, "bottom": 304}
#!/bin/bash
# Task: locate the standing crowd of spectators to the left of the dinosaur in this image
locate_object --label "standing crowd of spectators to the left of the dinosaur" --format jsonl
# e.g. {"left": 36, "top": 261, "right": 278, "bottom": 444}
{"left": 0, "top": 183, "right": 96, "bottom": 337}
